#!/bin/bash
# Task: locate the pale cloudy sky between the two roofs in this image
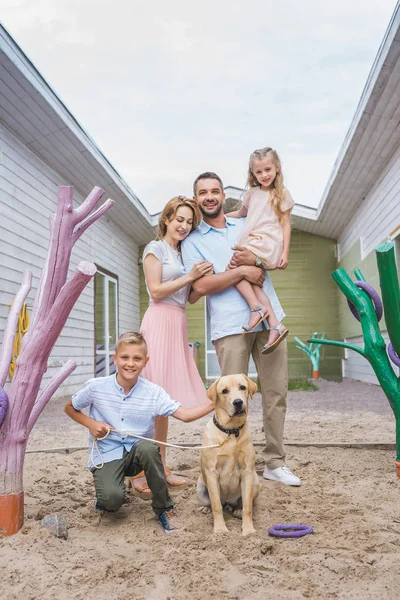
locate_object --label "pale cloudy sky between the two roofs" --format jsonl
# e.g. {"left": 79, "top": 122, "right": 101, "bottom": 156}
{"left": 0, "top": 0, "right": 396, "bottom": 213}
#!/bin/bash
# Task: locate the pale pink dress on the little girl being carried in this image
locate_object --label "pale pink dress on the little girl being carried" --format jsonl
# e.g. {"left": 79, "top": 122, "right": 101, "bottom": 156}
{"left": 239, "top": 188, "right": 294, "bottom": 269}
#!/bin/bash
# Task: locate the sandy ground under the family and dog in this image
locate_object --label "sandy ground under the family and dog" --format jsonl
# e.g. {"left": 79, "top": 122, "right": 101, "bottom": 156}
{"left": 0, "top": 381, "right": 400, "bottom": 600}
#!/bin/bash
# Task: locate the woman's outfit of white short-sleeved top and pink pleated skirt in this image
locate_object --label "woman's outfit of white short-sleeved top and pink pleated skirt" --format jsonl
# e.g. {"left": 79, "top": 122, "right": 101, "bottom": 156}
{"left": 140, "top": 240, "right": 207, "bottom": 407}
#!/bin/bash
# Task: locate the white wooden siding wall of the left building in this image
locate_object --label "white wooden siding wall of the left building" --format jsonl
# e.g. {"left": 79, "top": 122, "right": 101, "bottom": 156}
{"left": 0, "top": 126, "right": 139, "bottom": 396}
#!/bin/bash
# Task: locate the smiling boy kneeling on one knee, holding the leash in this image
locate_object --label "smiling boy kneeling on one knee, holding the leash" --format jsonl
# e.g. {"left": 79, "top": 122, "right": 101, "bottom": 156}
{"left": 64, "top": 332, "right": 214, "bottom": 534}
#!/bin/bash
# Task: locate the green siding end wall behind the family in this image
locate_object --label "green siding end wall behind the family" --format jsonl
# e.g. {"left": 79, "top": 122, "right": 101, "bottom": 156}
{"left": 140, "top": 230, "right": 343, "bottom": 380}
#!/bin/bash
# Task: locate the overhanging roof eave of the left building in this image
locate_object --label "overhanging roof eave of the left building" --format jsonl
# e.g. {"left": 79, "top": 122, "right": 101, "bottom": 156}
{"left": 0, "top": 25, "right": 154, "bottom": 244}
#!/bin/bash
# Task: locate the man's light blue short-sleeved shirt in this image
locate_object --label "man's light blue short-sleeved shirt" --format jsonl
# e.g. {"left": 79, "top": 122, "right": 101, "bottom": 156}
{"left": 182, "top": 217, "right": 285, "bottom": 340}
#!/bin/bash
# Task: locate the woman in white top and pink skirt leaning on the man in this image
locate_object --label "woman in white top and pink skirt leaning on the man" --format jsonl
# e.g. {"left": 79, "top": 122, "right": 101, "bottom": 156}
{"left": 131, "top": 196, "right": 213, "bottom": 498}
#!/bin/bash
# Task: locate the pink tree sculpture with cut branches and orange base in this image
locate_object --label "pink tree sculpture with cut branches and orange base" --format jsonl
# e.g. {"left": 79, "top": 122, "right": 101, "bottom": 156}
{"left": 0, "top": 187, "right": 114, "bottom": 536}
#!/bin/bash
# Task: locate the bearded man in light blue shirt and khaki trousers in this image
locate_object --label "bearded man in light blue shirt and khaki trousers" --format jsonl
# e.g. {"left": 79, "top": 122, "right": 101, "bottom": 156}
{"left": 182, "top": 172, "right": 301, "bottom": 485}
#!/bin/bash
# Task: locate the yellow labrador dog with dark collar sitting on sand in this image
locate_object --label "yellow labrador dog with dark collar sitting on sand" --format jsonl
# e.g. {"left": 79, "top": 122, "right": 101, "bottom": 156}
{"left": 197, "top": 375, "right": 261, "bottom": 535}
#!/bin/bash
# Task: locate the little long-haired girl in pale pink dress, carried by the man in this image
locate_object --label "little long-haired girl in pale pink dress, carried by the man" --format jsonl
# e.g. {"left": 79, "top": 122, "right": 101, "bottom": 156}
{"left": 227, "top": 148, "right": 294, "bottom": 354}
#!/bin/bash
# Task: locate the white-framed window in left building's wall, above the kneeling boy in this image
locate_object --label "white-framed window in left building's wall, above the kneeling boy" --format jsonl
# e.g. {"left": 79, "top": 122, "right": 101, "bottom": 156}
{"left": 94, "top": 271, "right": 118, "bottom": 377}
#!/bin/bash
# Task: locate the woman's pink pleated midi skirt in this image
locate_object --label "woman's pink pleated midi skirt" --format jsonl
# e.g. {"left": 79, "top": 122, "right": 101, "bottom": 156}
{"left": 140, "top": 302, "right": 207, "bottom": 407}
